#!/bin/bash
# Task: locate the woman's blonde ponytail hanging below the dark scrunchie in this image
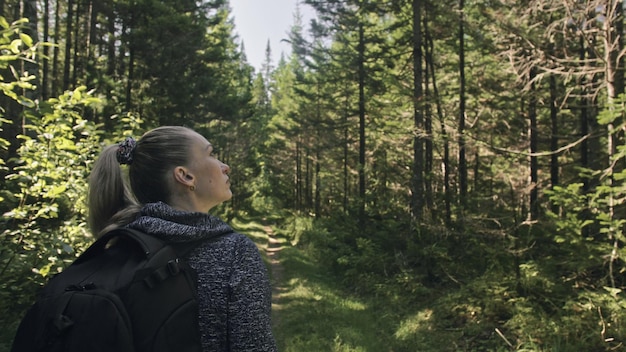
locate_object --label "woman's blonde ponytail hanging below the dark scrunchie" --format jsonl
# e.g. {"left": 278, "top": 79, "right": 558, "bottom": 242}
{"left": 88, "top": 145, "right": 140, "bottom": 238}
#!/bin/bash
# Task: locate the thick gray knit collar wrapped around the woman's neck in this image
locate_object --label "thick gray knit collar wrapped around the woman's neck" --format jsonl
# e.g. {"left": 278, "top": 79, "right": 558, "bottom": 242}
{"left": 128, "top": 202, "right": 233, "bottom": 242}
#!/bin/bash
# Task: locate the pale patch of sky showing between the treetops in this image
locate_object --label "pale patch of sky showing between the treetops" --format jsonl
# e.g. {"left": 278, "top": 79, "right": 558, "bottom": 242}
{"left": 230, "top": 0, "right": 315, "bottom": 72}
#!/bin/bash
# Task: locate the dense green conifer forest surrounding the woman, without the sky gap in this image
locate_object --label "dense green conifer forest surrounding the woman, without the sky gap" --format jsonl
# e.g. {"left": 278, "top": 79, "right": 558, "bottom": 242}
{"left": 0, "top": 0, "right": 626, "bottom": 352}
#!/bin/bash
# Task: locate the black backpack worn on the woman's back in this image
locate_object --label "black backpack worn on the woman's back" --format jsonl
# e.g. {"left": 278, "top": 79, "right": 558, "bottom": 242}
{"left": 11, "top": 229, "right": 201, "bottom": 352}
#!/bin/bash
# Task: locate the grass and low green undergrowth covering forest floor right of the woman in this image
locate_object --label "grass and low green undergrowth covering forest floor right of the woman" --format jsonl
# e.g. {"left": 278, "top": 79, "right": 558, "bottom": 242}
{"left": 275, "top": 212, "right": 626, "bottom": 352}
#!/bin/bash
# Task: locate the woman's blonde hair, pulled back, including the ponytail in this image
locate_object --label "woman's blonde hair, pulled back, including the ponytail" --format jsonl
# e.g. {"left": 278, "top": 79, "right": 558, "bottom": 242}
{"left": 88, "top": 126, "right": 195, "bottom": 237}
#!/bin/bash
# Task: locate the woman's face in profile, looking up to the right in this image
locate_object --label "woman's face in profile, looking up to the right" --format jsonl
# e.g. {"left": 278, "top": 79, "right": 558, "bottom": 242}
{"left": 187, "top": 132, "right": 233, "bottom": 212}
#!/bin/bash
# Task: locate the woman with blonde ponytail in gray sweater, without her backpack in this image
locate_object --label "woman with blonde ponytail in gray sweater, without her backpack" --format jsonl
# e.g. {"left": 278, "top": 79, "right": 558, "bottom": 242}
{"left": 89, "top": 126, "right": 276, "bottom": 351}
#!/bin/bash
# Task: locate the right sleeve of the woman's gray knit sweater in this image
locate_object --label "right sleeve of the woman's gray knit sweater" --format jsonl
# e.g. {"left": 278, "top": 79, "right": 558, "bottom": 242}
{"left": 228, "top": 238, "right": 277, "bottom": 352}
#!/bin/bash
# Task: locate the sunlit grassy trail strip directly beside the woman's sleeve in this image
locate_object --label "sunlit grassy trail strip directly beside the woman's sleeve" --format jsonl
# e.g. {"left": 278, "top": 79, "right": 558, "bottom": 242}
{"left": 273, "top": 236, "right": 391, "bottom": 352}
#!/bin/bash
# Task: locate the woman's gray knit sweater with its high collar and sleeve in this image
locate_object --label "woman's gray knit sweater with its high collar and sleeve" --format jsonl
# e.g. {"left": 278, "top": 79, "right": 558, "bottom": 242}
{"left": 128, "top": 203, "right": 276, "bottom": 351}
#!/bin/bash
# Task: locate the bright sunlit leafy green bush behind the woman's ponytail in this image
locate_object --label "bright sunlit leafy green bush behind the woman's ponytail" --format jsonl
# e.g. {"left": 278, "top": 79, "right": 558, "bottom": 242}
{"left": 0, "top": 87, "right": 105, "bottom": 346}
